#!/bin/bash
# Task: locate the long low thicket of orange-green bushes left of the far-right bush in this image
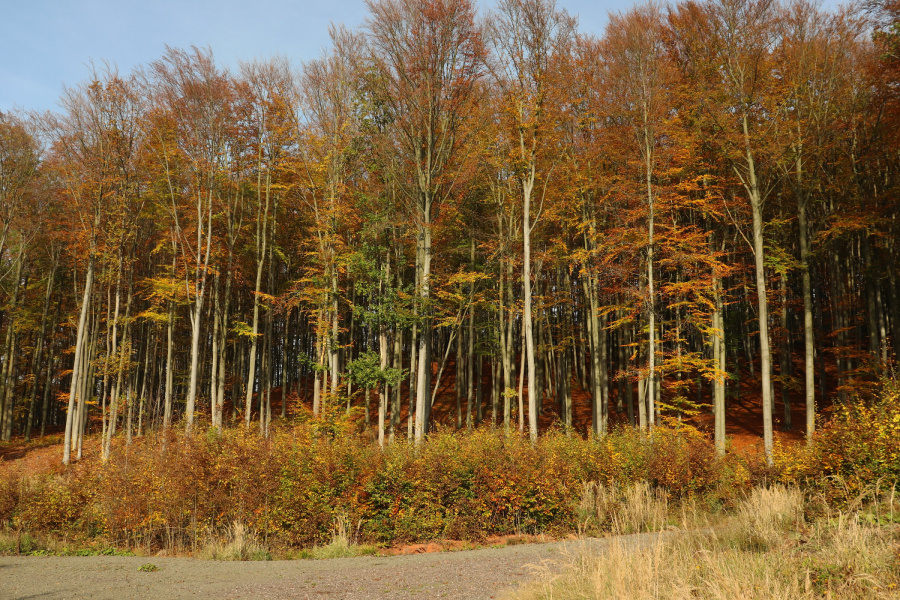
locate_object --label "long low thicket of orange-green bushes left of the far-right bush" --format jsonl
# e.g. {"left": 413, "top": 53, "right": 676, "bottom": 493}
{"left": 0, "top": 421, "right": 749, "bottom": 552}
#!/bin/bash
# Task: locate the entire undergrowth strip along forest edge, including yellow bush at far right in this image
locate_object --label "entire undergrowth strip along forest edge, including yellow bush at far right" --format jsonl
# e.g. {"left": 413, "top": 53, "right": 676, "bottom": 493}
{"left": 0, "top": 390, "right": 900, "bottom": 560}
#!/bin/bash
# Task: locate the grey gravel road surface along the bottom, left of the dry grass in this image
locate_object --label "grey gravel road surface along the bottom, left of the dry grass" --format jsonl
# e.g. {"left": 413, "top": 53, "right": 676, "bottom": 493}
{"left": 0, "top": 534, "right": 653, "bottom": 600}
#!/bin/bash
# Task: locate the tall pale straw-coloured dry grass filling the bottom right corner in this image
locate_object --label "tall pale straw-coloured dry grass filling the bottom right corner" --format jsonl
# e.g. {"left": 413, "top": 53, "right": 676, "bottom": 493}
{"left": 511, "top": 486, "right": 900, "bottom": 600}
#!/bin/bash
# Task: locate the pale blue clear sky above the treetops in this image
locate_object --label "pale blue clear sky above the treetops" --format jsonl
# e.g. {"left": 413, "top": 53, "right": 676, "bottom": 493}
{"left": 0, "top": 0, "right": 632, "bottom": 111}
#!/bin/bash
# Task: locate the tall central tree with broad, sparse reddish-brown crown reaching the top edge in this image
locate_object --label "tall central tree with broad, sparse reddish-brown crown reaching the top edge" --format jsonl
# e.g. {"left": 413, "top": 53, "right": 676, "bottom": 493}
{"left": 366, "top": 0, "right": 485, "bottom": 443}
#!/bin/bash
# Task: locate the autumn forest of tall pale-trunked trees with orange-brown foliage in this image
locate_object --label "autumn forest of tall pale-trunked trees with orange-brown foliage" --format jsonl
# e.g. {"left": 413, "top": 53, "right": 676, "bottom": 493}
{"left": 0, "top": 0, "right": 900, "bottom": 464}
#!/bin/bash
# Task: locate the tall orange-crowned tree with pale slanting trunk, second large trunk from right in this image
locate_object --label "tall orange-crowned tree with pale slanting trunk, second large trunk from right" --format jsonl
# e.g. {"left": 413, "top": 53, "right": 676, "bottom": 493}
{"left": 672, "top": 0, "right": 778, "bottom": 463}
